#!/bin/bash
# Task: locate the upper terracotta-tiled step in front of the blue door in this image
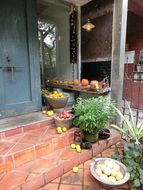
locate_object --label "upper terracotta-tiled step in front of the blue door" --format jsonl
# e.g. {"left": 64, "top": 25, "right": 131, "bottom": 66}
{"left": 0, "top": 119, "right": 75, "bottom": 174}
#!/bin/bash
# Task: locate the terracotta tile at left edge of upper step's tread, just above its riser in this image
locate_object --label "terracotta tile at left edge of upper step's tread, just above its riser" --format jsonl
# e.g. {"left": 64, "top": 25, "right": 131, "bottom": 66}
{"left": 0, "top": 141, "right": 15, "bottom": 155}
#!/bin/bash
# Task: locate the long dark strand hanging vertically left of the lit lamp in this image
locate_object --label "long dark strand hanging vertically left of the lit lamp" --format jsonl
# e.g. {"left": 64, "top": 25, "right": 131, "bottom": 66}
{"left": 70, "top": 7, "right": 77, "bottom": 64}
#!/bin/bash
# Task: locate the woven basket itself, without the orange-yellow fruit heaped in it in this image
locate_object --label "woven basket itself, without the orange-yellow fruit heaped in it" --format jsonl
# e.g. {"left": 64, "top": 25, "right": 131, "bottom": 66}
{"left": 45, "top": 94, "right": 69, "bottom": 108}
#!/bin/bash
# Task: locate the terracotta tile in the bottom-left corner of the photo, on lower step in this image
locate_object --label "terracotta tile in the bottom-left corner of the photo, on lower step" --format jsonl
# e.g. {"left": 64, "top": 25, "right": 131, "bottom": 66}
{"left": 0, "top": 171, "right": 27, "bottom": 190}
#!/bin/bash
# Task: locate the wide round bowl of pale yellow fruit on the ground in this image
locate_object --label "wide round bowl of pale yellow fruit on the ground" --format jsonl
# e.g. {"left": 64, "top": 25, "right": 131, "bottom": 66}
{"left": 90, "top": 158, "right": 130, "bottom": 187}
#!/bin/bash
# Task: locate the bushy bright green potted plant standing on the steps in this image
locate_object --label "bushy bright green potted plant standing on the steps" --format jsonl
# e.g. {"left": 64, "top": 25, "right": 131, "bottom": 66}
{"left": 73, "top": 96, "right": 115, "bottom": 142}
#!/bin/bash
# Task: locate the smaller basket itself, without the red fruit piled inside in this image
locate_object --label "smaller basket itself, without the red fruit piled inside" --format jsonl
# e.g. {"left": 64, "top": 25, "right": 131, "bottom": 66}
{"left": 54, "top": 115, "right": 75, "bottom": 129}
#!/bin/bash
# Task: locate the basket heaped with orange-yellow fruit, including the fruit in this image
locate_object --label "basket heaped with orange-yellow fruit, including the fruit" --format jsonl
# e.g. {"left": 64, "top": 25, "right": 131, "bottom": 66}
{"left": 46, "top": 91, "right": 69, "bottom": 109}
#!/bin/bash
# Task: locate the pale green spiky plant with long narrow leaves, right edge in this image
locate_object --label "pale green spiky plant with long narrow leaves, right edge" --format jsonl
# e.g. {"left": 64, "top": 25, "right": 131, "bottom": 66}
{"left": 111, "top": 102, "right": 143, "bottom": 144}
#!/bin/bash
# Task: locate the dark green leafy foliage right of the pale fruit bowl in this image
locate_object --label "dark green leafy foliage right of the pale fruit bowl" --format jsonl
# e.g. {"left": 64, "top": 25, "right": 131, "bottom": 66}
{"left": 114, "top": 143, "right": 143, "bottom": 187}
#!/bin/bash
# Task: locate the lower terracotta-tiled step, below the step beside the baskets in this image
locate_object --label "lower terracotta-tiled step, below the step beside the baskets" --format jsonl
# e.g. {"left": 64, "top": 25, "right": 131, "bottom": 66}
{"left": 0, "top": 129, "right": 121, "bottom": 190}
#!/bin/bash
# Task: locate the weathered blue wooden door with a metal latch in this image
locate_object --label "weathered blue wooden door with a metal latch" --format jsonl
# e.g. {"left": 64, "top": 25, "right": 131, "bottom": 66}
{"left": 0, "top": 0, "right": 41, "bottom": 118}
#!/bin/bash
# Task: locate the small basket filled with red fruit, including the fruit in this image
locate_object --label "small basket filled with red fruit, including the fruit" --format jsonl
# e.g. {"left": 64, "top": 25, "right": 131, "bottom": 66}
{"left": 54, "top": 110, "right": 74, "bottom": 129}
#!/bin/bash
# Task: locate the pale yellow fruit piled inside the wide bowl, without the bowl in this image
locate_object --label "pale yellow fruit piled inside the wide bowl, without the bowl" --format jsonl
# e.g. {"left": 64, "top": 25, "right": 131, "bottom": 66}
{"left": 95, "top": 160, "right": 123, "bottom": 182}
